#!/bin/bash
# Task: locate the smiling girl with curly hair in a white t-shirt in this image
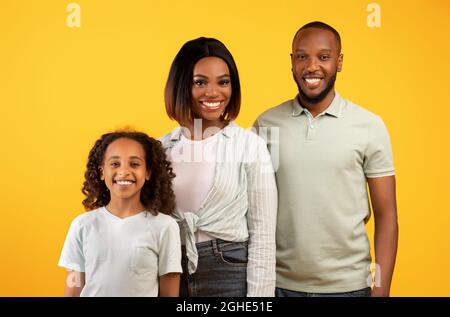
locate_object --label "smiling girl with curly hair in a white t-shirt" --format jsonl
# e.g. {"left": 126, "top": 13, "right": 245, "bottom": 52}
{"left": 59, "top": 131, "right": 181, "bottom": 296}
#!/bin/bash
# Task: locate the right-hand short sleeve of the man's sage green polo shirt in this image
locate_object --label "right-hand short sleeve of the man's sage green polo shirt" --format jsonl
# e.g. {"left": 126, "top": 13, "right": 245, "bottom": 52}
{"left": 363, "top": 117, "right": 394, "bottom": 178}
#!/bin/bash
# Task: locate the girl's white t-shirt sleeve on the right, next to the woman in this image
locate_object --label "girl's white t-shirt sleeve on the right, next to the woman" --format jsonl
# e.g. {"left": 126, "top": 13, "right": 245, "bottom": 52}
{"left": 158, "top": 218, "right": 182, "bottom": 276}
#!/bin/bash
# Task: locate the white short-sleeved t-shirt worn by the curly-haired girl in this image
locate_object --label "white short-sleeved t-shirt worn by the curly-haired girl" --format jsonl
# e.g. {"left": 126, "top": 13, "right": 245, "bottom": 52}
{"left": 58, "top": 207, "right": 182, "bottom": 296}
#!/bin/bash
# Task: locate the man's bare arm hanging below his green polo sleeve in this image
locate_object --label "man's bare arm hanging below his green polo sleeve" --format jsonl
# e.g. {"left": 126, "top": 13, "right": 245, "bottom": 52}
{"left": 367, "top": 176, "right": 398, "bottom": 296}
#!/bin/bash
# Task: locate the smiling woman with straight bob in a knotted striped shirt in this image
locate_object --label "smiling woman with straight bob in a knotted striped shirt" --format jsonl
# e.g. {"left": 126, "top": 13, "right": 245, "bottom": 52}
{"left": 162, "top": 37, "right": 277, "bottom": 296}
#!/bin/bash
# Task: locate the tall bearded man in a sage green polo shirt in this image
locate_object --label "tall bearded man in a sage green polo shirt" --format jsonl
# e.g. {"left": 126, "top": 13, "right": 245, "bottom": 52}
{"left": 255, "top": 22, "right": 398, "bottom": 296}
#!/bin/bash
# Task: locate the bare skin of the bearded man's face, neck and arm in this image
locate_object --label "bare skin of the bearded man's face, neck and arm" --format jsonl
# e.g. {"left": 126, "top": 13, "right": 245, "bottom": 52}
{"left": 291, "top": 28, "right": 398, "bottom": 297}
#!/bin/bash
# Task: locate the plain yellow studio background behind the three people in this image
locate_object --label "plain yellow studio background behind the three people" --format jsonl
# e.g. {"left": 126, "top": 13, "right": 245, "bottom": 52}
{"left": 0, "top": 0, "right": 450, "bottom": 296}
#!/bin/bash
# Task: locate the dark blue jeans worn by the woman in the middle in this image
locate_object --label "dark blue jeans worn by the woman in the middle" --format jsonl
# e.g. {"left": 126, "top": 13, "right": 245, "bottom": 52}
{"left": 180, "top": 239, "right": 248, "bottom": 297}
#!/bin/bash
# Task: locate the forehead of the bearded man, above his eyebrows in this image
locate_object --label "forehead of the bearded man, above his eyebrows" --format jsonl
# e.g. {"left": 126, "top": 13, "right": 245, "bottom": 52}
{"left": 292, "top": 28, "right": 339, "bottom": 51}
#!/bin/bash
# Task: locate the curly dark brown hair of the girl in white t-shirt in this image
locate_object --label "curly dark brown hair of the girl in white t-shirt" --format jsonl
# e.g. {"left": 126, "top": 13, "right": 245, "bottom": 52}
{"left": 82, "top": 130, "right": 175, "bottom": 215}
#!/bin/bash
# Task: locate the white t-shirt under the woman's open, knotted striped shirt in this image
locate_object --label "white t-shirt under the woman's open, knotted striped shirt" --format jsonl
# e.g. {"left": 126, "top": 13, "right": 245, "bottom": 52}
{"left": 168, "top": 134, "right": 218, "bottom": 244}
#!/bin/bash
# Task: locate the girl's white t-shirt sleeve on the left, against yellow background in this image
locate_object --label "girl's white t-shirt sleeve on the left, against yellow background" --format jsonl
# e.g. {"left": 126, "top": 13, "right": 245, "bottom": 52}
{"left": 58, "top": 217, "right": 85, "bottom": 272}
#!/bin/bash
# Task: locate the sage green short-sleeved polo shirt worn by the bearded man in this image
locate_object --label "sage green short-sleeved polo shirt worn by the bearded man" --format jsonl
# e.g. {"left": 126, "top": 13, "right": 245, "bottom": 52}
{"left": 255, "top": 93, "right": 394, "bottom": 293}
